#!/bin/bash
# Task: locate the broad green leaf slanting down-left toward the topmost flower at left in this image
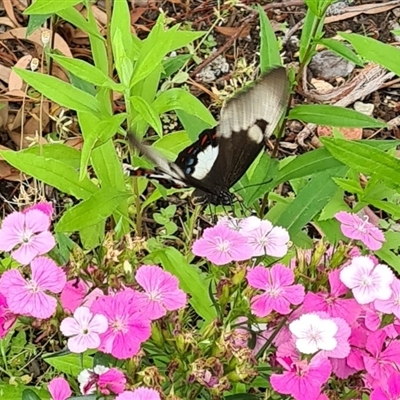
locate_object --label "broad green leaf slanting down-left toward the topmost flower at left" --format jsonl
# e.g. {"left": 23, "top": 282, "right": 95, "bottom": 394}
{"left": 55, "top": 188, "right": 131, "bottom": 232}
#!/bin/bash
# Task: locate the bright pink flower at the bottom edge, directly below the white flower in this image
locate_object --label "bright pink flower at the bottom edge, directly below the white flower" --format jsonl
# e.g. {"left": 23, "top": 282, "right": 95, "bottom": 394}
{"left": 270, "top": 354, "right": 332, "bottom": 400}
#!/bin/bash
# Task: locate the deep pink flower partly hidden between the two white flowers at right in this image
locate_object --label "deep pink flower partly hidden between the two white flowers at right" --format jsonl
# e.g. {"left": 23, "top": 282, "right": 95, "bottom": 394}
{"left": 303, "top": 269, "right": 361, "bottom": 325}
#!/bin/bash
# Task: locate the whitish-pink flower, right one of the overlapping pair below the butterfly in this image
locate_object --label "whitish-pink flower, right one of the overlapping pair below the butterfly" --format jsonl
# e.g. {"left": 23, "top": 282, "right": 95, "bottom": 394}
{"left": 240, "top": 217, "right": 290, "bottom": 257}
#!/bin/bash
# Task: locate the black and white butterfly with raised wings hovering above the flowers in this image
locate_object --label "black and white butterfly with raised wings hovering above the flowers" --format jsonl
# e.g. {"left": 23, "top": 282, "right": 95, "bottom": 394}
{"left": 128, "top": 67, "right": 289, "bottom": 205}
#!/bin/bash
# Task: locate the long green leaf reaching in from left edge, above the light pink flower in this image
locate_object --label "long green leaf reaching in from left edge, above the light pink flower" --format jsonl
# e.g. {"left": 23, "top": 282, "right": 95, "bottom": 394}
{"left": 0, "top": 150, "right": 98, "bottom": 199}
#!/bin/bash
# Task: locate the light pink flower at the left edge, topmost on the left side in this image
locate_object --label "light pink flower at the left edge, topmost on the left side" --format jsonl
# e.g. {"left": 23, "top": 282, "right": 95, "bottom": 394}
{"left": 0, "top": 210, "right": 56, "bottom": 265}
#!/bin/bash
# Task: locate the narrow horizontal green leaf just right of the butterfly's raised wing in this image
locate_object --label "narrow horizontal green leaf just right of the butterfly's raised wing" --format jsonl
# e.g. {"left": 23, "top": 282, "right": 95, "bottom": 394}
{"left": 288, "top": 104, "right": 387, "bottom": 128}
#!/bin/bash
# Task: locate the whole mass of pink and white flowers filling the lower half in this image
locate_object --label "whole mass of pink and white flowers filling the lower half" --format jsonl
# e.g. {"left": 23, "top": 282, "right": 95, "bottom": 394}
{"left": 0, "top": 203, "right": 400, "bottom": 400}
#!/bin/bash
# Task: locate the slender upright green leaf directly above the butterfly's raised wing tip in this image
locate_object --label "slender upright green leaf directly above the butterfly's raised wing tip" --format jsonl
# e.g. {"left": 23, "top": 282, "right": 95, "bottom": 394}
{"left": 257, "top": 4, "right": 282, "bottom": 73}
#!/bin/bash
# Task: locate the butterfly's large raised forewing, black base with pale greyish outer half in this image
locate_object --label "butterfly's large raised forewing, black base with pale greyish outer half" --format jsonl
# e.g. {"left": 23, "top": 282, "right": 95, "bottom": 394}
{"left": 189, "top": 67, "right": 289, "bottom": 197}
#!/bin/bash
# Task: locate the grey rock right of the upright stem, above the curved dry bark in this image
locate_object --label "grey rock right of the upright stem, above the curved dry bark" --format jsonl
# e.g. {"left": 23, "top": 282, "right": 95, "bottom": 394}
{"left": 310, "top": 50, "right": 355, "bottom": 81}
